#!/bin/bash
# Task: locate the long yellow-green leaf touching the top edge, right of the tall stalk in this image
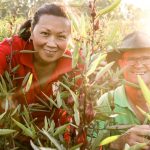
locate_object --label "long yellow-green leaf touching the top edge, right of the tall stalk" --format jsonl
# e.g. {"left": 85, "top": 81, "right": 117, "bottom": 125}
{"left": 96, "top": 0, "right": 121, "bottom": 17}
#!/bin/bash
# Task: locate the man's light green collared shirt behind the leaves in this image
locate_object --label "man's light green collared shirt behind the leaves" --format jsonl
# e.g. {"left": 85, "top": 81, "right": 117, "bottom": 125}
{"left": 97, "top": 86, "right": 140, "bottom": 125}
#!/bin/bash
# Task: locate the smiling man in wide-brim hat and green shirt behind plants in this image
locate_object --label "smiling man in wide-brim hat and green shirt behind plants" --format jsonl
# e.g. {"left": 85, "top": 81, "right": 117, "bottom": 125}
{"left": 97, "top": 31, "right": 150, "bottom": 150}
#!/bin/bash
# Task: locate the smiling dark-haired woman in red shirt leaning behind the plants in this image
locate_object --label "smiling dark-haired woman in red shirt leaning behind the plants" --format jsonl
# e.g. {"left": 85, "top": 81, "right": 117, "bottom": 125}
{"left": 0, "top": 4, "right": 85, "bottom": 148}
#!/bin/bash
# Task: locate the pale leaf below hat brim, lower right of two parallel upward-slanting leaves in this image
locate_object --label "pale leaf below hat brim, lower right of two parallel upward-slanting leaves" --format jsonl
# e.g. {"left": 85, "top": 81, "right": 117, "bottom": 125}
{"left": 95, "top": 62, "right": 115, "bottom": 81}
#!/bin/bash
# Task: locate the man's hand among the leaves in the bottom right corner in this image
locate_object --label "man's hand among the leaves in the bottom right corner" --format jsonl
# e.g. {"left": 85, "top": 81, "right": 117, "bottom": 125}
{"left": 110, "top": 125, "right": 150, "bottom": 150}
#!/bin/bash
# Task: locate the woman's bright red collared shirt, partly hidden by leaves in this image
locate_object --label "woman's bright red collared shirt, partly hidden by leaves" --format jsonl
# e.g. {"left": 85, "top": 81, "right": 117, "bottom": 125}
{"left": 0, "top": 36, "right": 72, "bottom": 125}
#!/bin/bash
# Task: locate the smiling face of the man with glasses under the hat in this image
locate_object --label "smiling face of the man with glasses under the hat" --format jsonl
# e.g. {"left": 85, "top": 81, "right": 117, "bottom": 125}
{"left": 118, "top": 49, "right": 150, "bottom": 84}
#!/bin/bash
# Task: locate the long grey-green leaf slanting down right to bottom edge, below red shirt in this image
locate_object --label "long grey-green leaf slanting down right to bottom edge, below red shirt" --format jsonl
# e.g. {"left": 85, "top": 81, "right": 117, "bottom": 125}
{"left": 42, "top": 130, "right": 62, "bottom": 150}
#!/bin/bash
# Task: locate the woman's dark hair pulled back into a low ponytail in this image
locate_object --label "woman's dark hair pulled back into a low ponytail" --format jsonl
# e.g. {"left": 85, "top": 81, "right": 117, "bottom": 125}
{"left": 19, "top": 4, "right": 67, "bottom": 41}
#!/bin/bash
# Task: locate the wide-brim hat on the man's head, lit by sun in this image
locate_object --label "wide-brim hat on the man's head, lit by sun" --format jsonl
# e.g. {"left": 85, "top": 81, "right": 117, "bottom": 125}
{"left": 106, "top": 31, "right": 150, "bottom": 68}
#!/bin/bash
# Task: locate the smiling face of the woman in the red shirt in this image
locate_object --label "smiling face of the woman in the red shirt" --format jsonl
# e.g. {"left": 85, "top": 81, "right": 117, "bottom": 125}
{"left": 31, "top": 15, "right": 71, "bottom": 64}
